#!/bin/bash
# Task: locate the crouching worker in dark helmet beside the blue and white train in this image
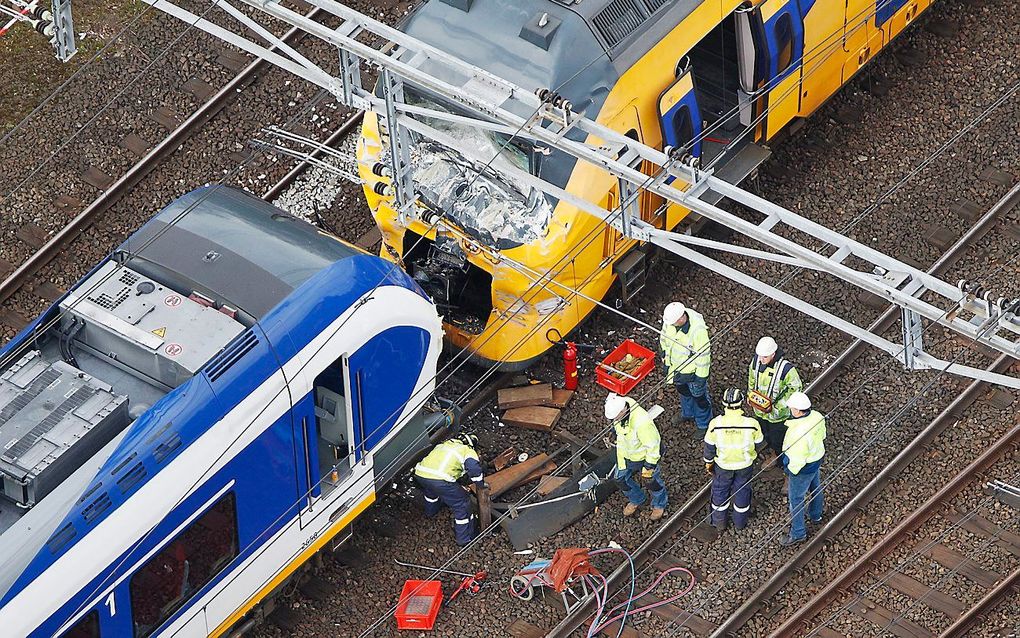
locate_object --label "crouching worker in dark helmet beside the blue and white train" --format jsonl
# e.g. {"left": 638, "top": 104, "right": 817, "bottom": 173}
{"left": 414, "top": 434, "right": 485, "bottom": 547}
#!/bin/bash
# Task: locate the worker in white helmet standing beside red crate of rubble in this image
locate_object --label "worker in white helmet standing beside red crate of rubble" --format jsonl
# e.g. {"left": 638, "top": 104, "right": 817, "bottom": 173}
{"left": 659, "top": 301, "right": 712, "bottom": 430}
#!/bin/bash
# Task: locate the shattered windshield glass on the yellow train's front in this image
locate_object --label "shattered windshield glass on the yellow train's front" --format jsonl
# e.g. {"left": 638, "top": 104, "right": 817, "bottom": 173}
{"left": 406, "top": 91, "right": 553, "bottom": 249}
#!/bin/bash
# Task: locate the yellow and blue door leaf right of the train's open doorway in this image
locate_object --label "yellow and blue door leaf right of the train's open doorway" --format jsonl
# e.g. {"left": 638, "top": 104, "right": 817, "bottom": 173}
{"left": 760, "top": 0, "right": 804, "bottom": 139}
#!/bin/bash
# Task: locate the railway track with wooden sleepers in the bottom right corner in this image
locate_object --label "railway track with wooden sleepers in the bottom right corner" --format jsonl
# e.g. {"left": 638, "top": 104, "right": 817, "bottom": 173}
{"left": 772, "top": 422, "right": 1020, "bottom": 638}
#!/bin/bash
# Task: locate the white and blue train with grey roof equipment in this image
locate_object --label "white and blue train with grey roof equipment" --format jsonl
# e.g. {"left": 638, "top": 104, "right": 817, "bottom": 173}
{"left": 0, "top": 187, "right": 452, "bottom": 638}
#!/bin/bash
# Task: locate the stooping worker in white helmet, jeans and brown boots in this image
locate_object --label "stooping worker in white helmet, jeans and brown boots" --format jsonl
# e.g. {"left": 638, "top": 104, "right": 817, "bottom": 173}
{"left": 606, "top": 393, "right": 669, "bottom": 521}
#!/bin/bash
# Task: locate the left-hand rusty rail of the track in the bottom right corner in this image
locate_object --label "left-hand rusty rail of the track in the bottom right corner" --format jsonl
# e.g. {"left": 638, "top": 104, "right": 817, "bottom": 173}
{"left": 771, "top": 420, "right": 1020, "bottom": 636}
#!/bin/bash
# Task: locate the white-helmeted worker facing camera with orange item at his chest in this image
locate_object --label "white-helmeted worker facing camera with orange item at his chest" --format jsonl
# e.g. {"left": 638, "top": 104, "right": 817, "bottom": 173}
{"left": 748, "top": 337, "right": 804, "bottom": 456}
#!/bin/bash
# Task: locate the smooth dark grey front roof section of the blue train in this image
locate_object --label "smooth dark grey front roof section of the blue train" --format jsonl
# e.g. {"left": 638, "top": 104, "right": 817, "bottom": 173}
{"left": 119, "top": 186, "right": 360, "bottom": 320}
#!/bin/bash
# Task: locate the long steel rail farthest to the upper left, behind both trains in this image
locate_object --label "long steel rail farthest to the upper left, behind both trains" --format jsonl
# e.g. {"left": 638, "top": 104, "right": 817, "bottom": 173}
{"left": 0, "top": 8, "right": 321, "bottom": 303}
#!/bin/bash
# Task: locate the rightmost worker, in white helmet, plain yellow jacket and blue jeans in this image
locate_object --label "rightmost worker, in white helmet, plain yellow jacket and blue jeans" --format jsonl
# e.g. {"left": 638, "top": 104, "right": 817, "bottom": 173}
{"left": 779, "top": 392, "right": 825, "bottom": 547}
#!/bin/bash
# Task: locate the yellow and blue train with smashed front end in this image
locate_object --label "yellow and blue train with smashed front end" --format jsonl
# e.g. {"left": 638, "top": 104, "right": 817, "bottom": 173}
{"left": 358, "top": 0, "right": 930, "bottom": 369}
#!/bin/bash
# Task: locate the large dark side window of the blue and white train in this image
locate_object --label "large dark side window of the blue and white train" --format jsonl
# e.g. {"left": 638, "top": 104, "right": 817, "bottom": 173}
{"left": 131, "top": 493, "right": 238, "bottom": 638}
